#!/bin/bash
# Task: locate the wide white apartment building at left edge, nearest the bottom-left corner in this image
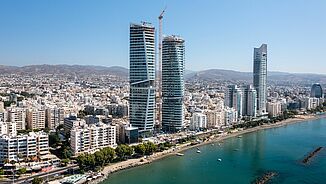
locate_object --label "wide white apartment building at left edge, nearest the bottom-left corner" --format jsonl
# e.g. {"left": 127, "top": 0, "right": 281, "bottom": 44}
{"left": 0, "top": 132, "right": 49, "bottom": 164}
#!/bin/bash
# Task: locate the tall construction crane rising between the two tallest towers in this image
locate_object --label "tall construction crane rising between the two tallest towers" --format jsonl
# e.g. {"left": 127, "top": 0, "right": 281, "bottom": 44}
{"left": 158, "top": 7, "right": 166, "bottom": 126}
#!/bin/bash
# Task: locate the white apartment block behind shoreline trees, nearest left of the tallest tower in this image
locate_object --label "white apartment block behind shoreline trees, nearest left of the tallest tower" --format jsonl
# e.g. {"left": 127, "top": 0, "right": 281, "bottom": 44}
{"left": 70, "top": 123, "right": 117, "bottom": 155}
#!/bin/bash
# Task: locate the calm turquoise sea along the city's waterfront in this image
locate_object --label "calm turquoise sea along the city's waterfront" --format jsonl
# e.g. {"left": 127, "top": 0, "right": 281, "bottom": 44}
{"left": 103, "top": 119, "right": 326, "bottom": 184}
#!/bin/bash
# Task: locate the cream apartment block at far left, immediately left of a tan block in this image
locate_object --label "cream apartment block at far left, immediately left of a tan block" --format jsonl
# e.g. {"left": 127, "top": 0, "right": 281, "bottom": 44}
{"left": 8, "top": 108, "right": 26, "bottom": 130}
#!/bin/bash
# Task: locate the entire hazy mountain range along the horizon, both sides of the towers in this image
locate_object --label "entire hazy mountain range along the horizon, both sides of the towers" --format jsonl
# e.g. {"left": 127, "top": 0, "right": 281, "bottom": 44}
{"left": 0, "top": 65, "right": 326, "bottom": 84}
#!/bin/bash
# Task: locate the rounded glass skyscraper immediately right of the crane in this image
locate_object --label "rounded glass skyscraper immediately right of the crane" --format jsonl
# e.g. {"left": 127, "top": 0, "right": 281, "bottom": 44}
{"left": 162, "top": 36, "right": 185, "bottom": 132}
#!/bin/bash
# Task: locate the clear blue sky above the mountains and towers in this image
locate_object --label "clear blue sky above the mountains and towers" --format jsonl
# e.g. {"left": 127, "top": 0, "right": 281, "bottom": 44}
{"left": 0, "top": 0, "right": 326, "bottom": 74}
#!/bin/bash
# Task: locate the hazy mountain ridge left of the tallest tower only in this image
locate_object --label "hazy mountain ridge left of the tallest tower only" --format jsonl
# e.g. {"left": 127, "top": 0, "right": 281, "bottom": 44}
{"left": 0, "top": 65, "right": 128, "bottom": 78}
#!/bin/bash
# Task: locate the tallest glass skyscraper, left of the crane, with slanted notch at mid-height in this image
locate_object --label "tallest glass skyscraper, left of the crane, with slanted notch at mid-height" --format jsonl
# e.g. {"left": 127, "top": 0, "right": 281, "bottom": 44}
{"left": 129, "top": 23, "right": 155, "bottom": 133}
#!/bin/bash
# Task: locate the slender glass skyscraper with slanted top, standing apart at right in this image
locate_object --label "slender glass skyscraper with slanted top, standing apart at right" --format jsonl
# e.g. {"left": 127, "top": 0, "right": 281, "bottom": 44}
{"left": 253, "top": 44, "right": 267, "bottom": 115}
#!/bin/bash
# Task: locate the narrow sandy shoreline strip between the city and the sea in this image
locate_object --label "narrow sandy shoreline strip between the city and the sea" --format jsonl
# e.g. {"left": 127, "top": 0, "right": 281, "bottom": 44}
{"left": 88, "top": 114, "right": 326, "bottom": 184}
